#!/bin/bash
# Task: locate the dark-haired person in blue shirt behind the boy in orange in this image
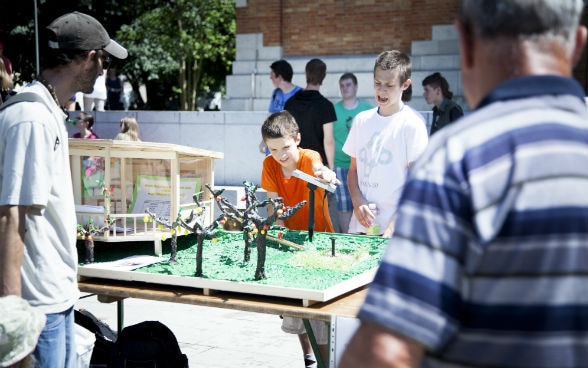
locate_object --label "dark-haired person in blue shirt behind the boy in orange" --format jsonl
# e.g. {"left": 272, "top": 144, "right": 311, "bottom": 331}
{"left": 259, "top": 59, "right": 302, "bottom": 155}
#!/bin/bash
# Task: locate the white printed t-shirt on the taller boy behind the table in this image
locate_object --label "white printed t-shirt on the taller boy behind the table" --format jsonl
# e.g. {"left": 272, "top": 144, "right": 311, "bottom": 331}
{"left": 343, "top": 105, "right": 428, "bottom": 233}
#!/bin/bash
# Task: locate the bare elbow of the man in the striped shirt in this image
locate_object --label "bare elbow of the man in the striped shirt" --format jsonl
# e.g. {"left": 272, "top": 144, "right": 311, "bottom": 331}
{"left": 338, "top": 322, "right": 425, "bottom": 368}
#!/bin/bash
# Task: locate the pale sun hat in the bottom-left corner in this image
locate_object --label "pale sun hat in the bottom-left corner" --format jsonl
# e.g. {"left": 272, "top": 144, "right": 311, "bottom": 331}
{"left": 0, "top": 295, "right": 46, "bottom": 368}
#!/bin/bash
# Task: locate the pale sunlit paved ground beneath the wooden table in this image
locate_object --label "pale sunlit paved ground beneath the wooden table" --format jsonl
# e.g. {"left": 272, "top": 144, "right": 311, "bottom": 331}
{"left": 76, "top": 294, "right": 304, "bottom": 368}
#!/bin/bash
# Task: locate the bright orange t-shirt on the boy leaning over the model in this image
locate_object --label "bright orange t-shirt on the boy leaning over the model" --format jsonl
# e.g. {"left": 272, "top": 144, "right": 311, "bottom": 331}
{"left": 261, "top": 148, "right": 334, "bottom": 233}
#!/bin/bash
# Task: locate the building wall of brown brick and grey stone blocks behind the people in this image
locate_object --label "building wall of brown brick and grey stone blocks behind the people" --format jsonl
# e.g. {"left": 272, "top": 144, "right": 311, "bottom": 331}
{"left": 223, "top": 0, "right": 588, "bottom": 111}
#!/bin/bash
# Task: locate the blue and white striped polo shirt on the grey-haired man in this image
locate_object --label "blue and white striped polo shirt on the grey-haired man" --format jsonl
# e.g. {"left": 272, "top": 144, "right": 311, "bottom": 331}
{"left": 358, "top": 76, "right": 588, "bottom": 368}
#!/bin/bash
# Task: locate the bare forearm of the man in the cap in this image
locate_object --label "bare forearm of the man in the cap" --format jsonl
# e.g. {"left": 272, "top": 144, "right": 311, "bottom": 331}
{"left": 0, "top": 206, "right": 27, "bottom": 296}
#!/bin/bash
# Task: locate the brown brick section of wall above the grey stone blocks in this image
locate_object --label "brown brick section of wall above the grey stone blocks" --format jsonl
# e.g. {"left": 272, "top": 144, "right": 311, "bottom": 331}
{"left": 236, "top": 0, "right": 459, "bottom": 57}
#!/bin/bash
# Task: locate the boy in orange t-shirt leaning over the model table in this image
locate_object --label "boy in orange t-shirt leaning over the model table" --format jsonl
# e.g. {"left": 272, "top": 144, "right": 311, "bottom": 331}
{"left": 261, "top": 110, "right": 340, "bottom": 367}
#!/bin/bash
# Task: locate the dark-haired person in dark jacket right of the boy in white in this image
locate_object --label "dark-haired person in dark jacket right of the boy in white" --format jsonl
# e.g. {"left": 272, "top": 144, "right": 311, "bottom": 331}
{"left": 423, "top": 73, "right": 463, "bottom": 135}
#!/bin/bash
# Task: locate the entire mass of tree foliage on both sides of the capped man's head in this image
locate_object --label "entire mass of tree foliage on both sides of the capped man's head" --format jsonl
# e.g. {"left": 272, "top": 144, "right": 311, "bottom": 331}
{"left": 0, "top": 0, "right": 236, "bottom": 110}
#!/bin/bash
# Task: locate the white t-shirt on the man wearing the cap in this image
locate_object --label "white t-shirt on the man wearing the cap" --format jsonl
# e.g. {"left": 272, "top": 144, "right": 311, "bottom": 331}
{"left": 0, "top": 82, "right": 79, "bottom": 313}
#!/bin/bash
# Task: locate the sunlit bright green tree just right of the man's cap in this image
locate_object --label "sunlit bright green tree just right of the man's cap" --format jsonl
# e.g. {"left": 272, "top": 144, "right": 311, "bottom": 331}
{"left": 116, "top": 0, "right": 235, "bottom": 110}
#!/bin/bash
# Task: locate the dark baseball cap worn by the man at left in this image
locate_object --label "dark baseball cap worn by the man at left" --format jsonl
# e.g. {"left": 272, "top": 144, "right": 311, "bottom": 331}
{"left": 47, "top": 12, "right": 129, "bottom": 59}
